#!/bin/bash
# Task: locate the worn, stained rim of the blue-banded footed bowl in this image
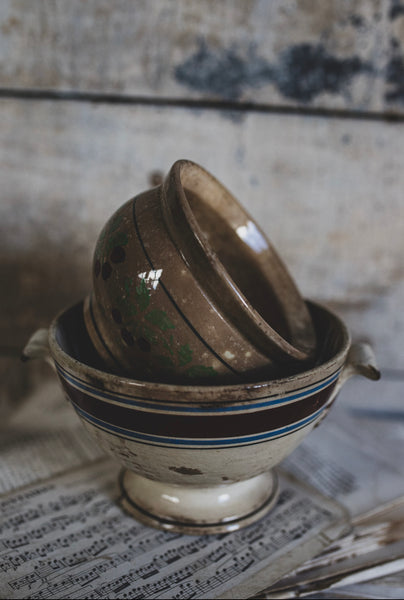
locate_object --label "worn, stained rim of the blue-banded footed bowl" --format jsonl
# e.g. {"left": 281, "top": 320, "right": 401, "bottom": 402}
{"left": 48, "top": 300, "right": 351, "bottom": 405}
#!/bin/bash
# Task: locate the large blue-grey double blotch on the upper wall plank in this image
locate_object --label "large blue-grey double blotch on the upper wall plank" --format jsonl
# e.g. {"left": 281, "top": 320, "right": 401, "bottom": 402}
{"left": 174, "top": 40, "right": 372, "bottom": 103}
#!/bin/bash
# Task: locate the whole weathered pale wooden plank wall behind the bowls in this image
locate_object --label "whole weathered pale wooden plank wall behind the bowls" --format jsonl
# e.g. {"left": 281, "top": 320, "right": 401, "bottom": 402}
{"left": 0, "top": 0, "right": 404, "bottom": 371}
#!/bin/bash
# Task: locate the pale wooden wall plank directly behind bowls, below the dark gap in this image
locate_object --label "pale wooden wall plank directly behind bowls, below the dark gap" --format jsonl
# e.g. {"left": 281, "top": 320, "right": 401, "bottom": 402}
{"left": 0, "top": 100, "right": 404, "bottom": 368}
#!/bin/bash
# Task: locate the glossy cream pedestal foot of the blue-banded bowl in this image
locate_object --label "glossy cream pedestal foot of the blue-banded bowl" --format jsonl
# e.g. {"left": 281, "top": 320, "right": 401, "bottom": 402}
{"left": 120, "top": 470, "right": 279, "bottom": 535}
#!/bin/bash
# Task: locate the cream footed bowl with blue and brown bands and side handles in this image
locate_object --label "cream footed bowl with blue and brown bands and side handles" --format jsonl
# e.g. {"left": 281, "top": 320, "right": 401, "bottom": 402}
{"left": 25, "top": 303, "right": 379, "bottom": 534}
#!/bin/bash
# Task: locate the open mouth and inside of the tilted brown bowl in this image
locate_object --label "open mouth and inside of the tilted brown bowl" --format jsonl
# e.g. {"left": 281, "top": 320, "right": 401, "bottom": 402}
{"left": 173, "top": 161, "right": 317, "bottom": 363}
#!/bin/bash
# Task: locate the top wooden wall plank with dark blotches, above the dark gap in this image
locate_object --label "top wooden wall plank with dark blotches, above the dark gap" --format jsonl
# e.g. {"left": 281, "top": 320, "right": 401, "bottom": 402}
{"left": 0, "top": 0, "right": 404, "bottom": 113}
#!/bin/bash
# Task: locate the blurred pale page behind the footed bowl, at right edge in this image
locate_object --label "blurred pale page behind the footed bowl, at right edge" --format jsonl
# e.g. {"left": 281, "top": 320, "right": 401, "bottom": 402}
{"left": 282, "top": 377, "right": 404, "bottom": 517}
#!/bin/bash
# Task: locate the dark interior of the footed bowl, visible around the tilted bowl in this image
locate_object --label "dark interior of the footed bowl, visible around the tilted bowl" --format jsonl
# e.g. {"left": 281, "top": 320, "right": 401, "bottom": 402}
{"left": 51, "top": 301, "right": 349, "bottom": 388}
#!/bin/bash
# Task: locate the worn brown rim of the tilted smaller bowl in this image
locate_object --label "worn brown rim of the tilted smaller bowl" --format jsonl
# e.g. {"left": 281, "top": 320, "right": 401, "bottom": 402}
{"left": 161, "top": 159, "right": 316, "bottom": 363}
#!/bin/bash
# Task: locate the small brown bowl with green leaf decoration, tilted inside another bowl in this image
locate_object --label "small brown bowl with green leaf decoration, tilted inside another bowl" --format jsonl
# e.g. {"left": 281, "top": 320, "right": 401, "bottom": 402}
{"left": 84, "top": 160, "right": 316, "bottom": 384}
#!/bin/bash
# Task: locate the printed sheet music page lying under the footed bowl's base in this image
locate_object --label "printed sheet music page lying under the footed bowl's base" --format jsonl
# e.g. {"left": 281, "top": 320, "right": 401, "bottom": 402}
{"left": 0, "top": 459, "right": 347, "bottom": 598}
